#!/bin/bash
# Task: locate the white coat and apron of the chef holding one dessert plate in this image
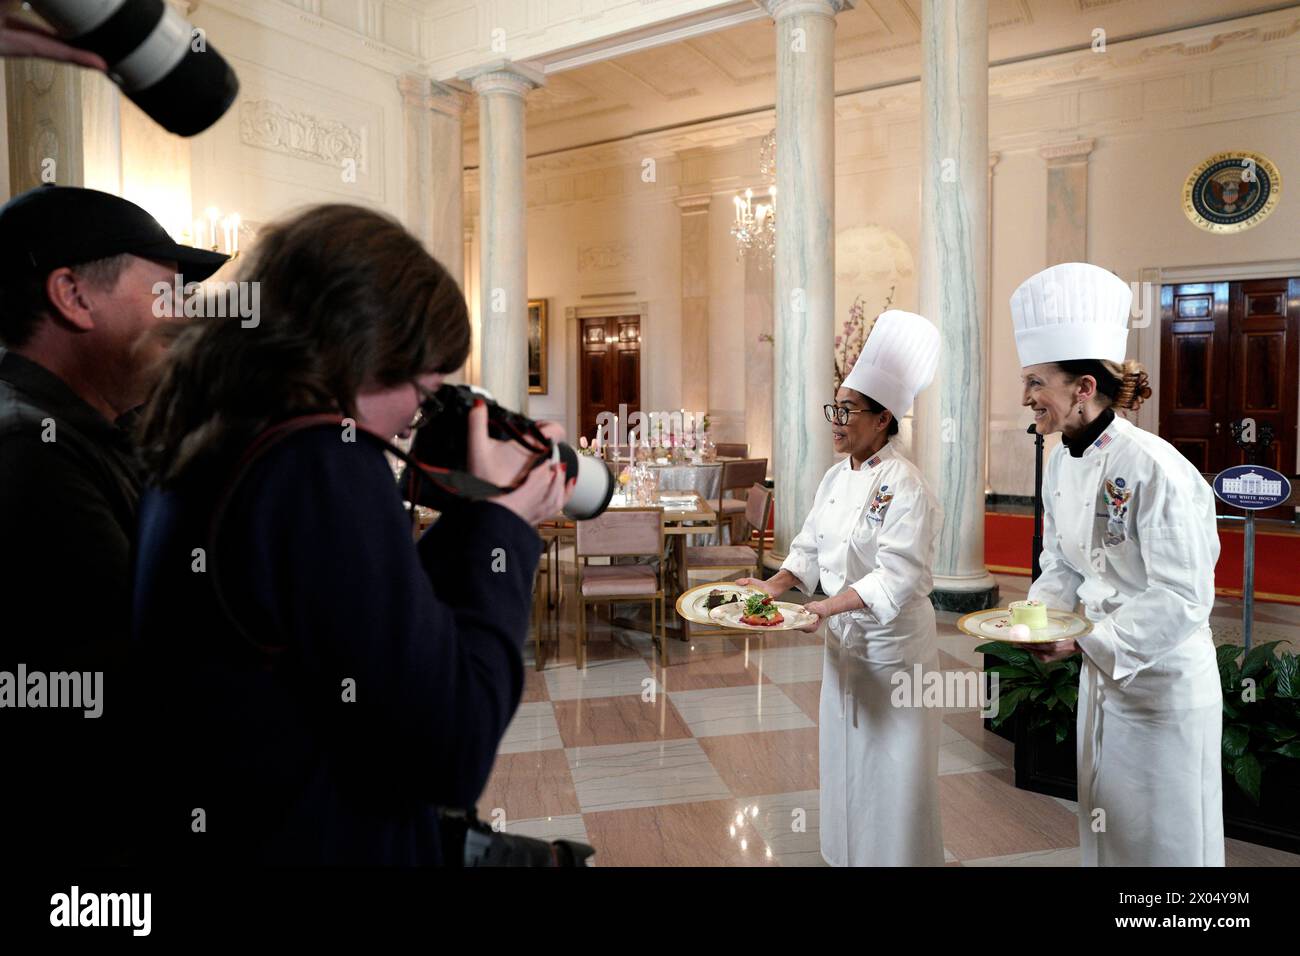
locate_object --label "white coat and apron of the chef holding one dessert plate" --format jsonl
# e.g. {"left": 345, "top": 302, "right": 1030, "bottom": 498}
{"left": 1030, "top": 416, "right": 1223, "bottom": 866}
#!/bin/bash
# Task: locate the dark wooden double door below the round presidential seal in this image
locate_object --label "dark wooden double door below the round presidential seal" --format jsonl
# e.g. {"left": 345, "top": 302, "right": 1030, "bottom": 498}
{"left": 1160, "top": 278, "right": 1300, "bottom": 520}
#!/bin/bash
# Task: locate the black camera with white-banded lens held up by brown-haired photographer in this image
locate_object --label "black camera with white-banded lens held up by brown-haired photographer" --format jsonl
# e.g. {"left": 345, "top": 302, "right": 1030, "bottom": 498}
{"left": 400, "top": 385, "right": 615, "bottom": 520}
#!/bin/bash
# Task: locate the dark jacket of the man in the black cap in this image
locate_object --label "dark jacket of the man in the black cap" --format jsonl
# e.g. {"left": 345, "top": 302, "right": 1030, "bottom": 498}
{"left": 0, "top": 349, "right": 140, "bottom": 865}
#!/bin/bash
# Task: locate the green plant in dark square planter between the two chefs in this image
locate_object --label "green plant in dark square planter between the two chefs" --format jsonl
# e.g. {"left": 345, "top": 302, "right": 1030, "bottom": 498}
{"left": 976, "top": 641, "right": 1082, "bottom": 800}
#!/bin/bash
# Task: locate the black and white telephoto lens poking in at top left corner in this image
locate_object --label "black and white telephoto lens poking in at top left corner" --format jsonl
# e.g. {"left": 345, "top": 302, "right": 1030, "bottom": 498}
{"left": 27, "top": 0, "right": 239, "bottom": 137}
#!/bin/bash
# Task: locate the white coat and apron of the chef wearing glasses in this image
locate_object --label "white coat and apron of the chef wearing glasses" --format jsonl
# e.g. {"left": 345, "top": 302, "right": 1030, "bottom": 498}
{"left": 781, "top": 442, "right": 944, "bottom": 866}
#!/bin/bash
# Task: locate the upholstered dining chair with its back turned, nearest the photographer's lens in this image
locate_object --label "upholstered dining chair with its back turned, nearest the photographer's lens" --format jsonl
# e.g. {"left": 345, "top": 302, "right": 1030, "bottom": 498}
{"left": 575, "top": 507, "right": 668, "bottom": 669}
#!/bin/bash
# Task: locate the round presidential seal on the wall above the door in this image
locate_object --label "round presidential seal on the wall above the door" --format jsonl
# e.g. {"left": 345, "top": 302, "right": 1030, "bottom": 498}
{"left": 1183, "top": 150, "right": 1282, "bottom": 233}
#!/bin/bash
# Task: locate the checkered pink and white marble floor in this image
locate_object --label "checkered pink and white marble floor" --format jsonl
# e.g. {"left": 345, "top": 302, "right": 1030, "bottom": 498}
{"left": 478, "top": 575, "right": 1300, "bottom": 866}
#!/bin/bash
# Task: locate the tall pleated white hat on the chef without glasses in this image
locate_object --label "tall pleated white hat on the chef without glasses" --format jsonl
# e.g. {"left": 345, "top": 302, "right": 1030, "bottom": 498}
{"left": 1011, "top": 263, "right": 1134, "bottom": 368}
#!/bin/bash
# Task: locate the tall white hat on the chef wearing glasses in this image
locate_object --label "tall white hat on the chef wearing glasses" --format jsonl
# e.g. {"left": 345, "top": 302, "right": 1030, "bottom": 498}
{"left": 844, "top": 308, "right": 939, "bottom": 418}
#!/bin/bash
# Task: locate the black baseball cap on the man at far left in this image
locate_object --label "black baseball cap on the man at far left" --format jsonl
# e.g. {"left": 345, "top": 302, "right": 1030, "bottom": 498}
{"left": 0, "top": 185, "right": 230, "bottom": 282}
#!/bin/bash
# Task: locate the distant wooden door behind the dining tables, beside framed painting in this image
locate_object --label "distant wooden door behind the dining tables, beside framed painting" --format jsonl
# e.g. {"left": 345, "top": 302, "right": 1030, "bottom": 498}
{"left": 577, "top": 315, "right": 641, "bottom": 441}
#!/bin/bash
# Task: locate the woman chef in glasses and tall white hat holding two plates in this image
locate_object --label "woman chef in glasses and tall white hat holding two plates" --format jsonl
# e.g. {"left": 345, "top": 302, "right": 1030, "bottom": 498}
{"left": 741, "top": 310, "right": 944, "bottom": 866}
